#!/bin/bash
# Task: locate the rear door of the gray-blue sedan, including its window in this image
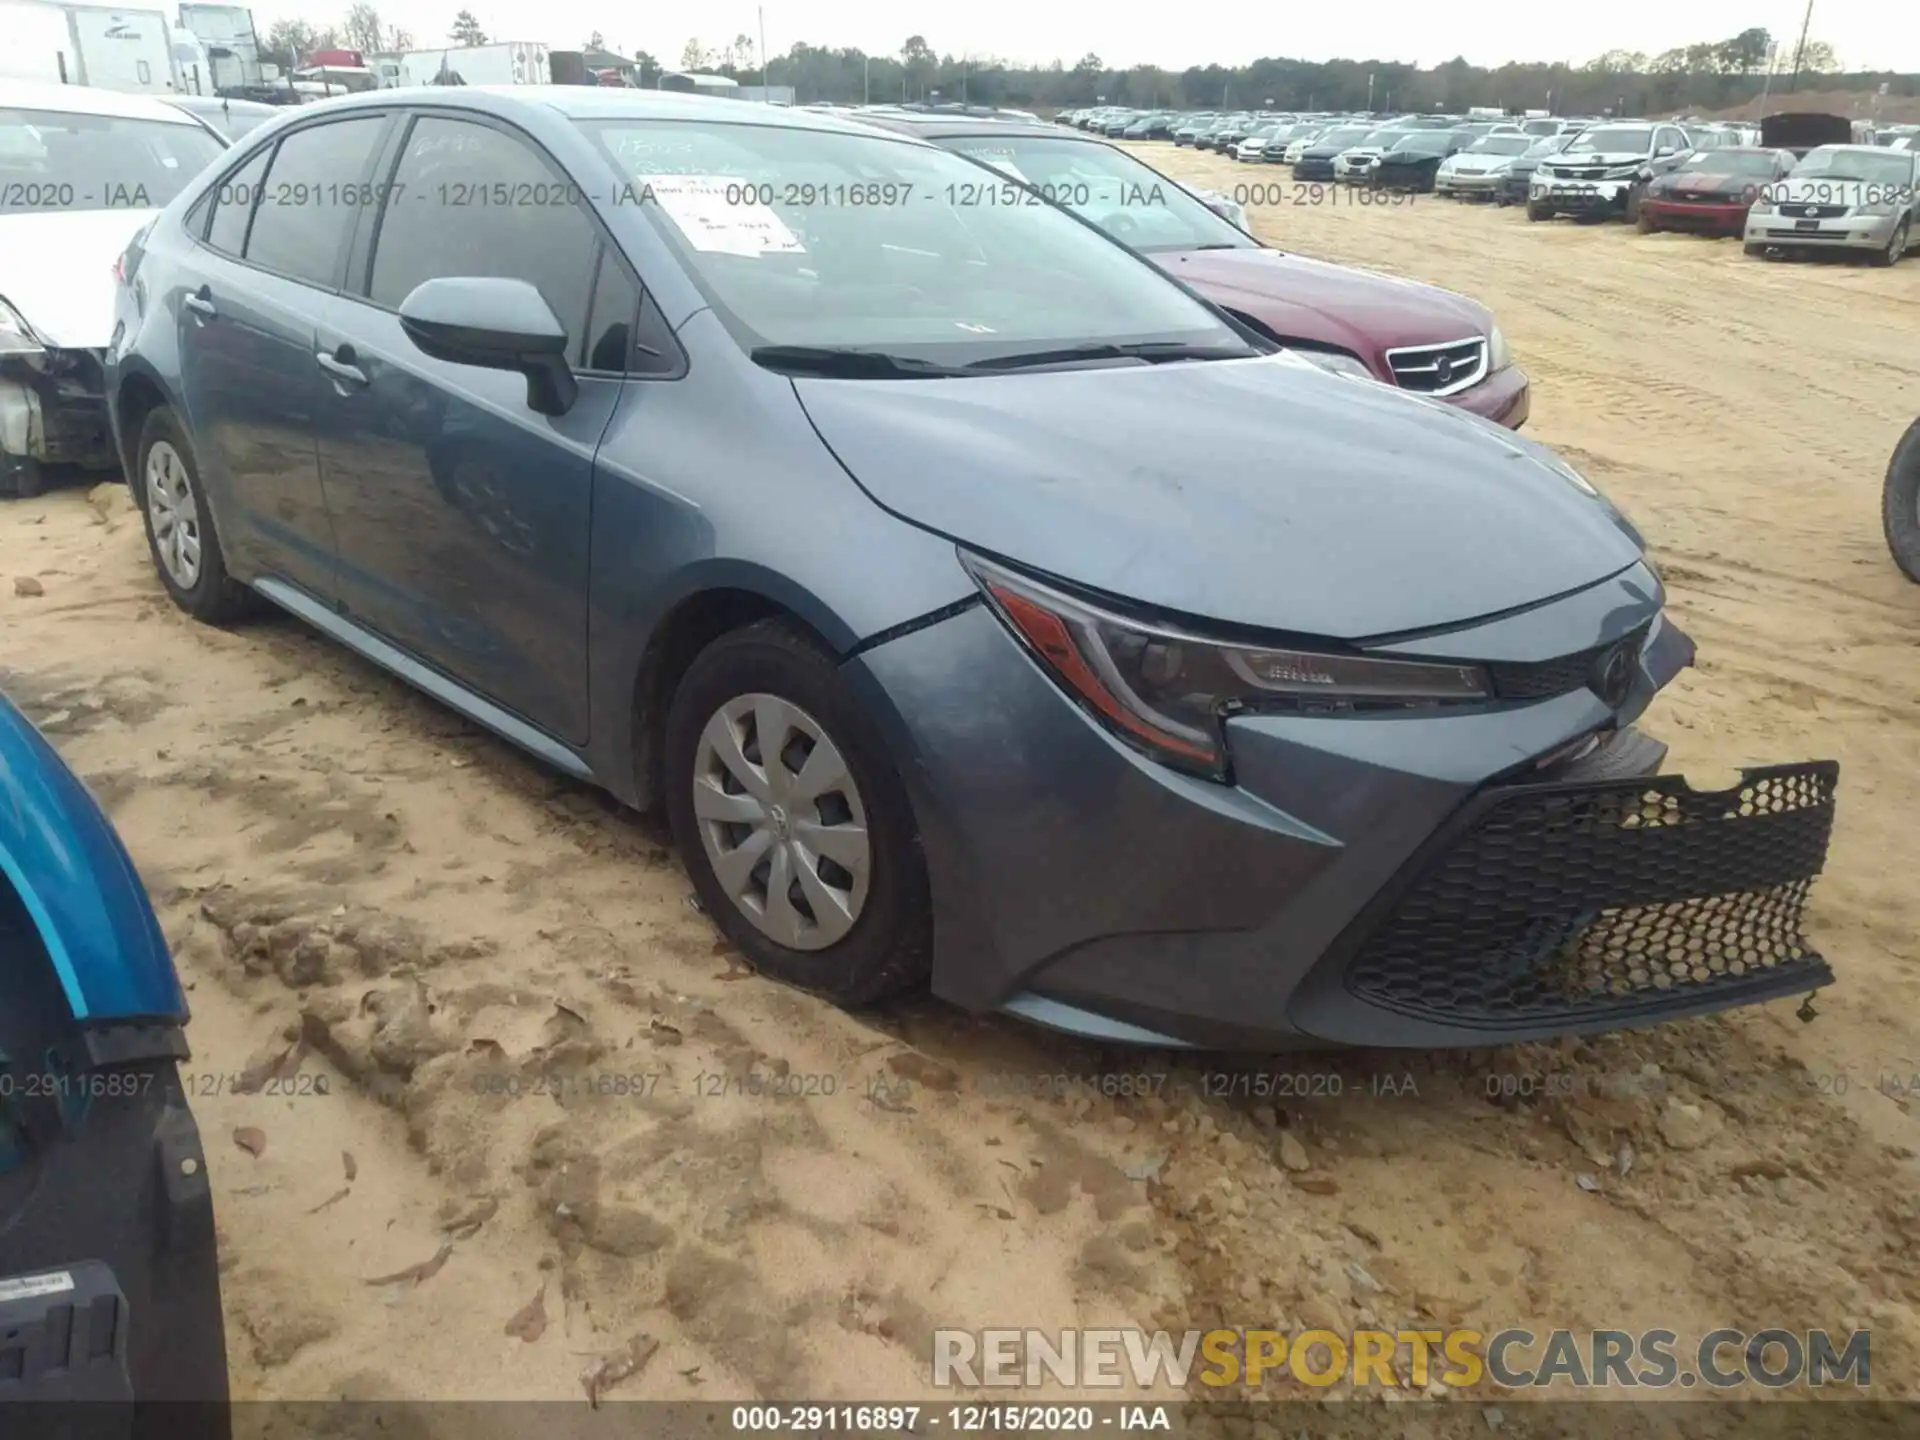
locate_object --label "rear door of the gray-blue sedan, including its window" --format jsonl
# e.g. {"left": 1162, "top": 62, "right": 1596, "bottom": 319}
{"left": 175, "top": 113, "right": 388, "bottom": 599}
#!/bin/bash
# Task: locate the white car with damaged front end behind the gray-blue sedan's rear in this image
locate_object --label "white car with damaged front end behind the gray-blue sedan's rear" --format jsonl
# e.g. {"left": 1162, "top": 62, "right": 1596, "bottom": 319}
{"left": 0, "top": 81, "right": 225, "bottom": 497}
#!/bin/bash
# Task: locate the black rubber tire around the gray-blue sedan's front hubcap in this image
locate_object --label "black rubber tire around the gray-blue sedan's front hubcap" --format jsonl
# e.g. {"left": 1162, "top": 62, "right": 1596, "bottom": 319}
{"left": 662, "top": 620, "right": 933, "bottom": 1006}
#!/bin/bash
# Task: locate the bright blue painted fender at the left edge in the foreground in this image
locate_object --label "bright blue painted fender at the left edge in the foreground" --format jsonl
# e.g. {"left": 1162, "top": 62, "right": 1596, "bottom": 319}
{"left": 0, "top": 697, "right": 186, "bottom": 1023}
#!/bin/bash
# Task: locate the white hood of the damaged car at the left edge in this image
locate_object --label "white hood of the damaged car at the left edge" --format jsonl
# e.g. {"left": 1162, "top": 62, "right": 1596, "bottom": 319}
{"left": 0, "top": 209, "right": 154, "bottom": 349}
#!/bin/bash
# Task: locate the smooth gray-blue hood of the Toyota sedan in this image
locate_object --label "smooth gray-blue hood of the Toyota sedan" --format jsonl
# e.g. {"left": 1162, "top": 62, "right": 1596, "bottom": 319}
{"left": 793, "top": 355, "right": 1642, "bottom": 639}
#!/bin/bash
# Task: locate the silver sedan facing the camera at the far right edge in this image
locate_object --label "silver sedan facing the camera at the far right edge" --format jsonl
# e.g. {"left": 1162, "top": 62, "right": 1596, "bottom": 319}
{"left": 1745, "top": 144, "right": 1920, "bottom": 265}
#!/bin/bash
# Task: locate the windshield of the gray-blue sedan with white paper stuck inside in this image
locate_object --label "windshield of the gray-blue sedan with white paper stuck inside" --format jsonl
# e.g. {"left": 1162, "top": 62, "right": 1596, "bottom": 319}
{"left": 580, "top": 119, "right": 1248, "bottom": 365}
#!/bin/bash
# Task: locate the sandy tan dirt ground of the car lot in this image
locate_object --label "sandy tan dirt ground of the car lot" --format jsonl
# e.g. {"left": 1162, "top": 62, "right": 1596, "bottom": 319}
{"left": 0, "top": 157, "right": 1920, "bottom": 1432}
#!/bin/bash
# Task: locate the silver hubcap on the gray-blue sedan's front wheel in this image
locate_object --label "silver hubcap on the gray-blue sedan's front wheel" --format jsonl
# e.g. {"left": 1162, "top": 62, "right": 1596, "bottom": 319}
{"left": 693, "top": 695, "right": 874, "bottom": 950}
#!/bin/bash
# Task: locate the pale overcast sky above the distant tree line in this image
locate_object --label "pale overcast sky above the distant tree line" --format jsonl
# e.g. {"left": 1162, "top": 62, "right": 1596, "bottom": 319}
{"left": 253, "top": 0, "right": 1920, "bottom": 71}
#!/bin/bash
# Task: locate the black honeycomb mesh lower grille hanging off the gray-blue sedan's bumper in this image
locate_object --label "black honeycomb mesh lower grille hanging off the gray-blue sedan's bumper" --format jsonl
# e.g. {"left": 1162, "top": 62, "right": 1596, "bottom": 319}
{"left": 1346, "top": 762, "right": 1839, "bottom": 1029}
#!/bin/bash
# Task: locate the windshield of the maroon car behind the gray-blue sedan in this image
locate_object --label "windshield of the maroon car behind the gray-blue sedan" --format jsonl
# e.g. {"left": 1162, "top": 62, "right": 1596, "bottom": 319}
{"left": 941, "top": 134, "right": 1260, "bottom": 253}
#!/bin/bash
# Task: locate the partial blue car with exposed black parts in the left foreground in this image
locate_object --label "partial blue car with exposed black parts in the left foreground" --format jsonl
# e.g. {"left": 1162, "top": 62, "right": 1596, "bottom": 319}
{"left": 0, "top": 697, "right": 228, "bottom": 1413}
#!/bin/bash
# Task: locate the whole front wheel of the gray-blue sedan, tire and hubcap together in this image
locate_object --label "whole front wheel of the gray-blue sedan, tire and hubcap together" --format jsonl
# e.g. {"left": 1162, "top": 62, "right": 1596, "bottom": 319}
{"left": 662, "top": 620, "right": 931, "bottom": 1006}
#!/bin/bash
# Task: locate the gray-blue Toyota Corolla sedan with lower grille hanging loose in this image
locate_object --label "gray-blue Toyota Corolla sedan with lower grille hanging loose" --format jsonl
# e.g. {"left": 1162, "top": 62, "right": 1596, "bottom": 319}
{"left": 108, "top": 88, "right": 1837, "bottom": 1048}
